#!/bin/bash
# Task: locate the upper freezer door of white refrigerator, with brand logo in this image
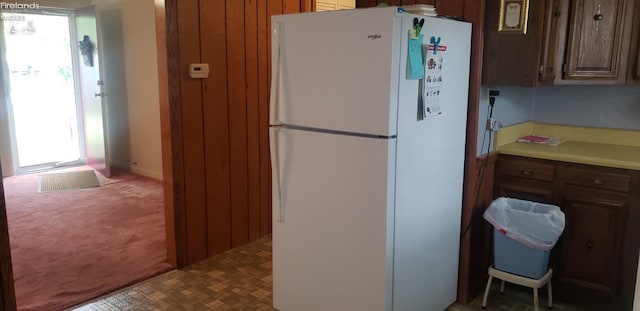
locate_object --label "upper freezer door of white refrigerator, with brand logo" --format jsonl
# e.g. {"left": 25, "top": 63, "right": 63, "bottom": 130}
{"left": 270, "top": 8, "right": 400, "bottom": 136}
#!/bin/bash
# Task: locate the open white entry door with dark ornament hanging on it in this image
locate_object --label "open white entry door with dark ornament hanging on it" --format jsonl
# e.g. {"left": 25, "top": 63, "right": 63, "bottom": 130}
{"left": 76, "top": 6, "right": 111, "bottom": 177}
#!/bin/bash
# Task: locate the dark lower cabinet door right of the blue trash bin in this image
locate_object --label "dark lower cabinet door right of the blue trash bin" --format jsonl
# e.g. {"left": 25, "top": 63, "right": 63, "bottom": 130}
{"left": 554, "top": 188, "right": 629, "bottom": 310}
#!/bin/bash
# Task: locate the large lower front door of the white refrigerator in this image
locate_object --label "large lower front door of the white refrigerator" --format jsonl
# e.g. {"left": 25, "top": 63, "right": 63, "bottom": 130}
{"left": 270, "top": 128, "right": 395, "bottom": 311}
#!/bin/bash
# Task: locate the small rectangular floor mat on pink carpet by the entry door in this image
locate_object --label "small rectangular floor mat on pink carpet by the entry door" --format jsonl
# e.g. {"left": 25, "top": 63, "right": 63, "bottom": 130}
{"left": 38, "top": 170, "right": 100, "bottom": 192}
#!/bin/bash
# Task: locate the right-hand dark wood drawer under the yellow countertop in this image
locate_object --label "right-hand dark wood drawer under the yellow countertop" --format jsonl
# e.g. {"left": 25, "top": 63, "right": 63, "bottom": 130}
{"left": 565, "top": 167, "right": 631, "bottom": 192}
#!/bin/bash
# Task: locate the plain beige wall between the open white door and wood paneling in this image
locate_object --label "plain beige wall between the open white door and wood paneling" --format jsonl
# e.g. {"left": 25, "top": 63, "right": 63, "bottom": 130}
{"left": 96, "top": 0, "right": 162, "bottom": 179}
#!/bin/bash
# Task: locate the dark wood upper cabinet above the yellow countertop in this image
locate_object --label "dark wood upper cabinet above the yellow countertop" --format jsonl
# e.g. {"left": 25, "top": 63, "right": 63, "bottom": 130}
{"left": 482, "top": 0, "right": 640, "bottom": 86}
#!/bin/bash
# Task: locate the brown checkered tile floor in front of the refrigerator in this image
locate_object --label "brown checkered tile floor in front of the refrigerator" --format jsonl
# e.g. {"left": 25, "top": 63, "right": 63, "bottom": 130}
{"left": 72, "top": 237, "right": 581, "bottom": 311}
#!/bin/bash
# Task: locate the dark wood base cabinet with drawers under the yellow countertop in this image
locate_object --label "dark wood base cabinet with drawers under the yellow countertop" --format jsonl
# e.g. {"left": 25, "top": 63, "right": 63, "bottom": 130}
{"left": 495, "top": 155, "right": 640, "bottom": 310}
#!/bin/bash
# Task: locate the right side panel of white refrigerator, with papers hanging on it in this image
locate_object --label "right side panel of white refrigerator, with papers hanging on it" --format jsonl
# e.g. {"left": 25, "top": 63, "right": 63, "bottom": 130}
{"left": 393, "top": 17, "right": 471, "bottom": 311}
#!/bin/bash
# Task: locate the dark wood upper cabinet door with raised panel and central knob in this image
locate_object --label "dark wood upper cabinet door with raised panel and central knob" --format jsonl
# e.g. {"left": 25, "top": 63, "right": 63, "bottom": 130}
{"left": 564, "top": 0, "right": 631, "bottom": 83}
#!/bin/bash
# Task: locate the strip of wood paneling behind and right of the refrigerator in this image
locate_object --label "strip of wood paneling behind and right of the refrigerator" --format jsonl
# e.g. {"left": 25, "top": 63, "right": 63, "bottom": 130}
{"left": 356, "top": 0, "right": 493, "bottom": 303}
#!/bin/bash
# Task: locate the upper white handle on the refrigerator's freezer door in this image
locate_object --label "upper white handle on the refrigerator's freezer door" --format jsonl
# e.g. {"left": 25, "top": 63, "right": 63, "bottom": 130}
{"left": 269, "top": 22, "right": 282, "bottom": 125}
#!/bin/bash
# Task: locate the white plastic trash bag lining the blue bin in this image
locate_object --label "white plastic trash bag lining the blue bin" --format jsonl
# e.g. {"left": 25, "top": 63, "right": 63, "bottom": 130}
{"left": 484, "top": 197, "right": 564, "bottom": 251}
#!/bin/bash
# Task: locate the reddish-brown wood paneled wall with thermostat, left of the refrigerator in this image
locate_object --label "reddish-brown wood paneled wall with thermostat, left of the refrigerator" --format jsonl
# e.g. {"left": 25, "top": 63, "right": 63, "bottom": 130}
{"left": 166, "top": 0, "right": 311, "bottom": 267}
